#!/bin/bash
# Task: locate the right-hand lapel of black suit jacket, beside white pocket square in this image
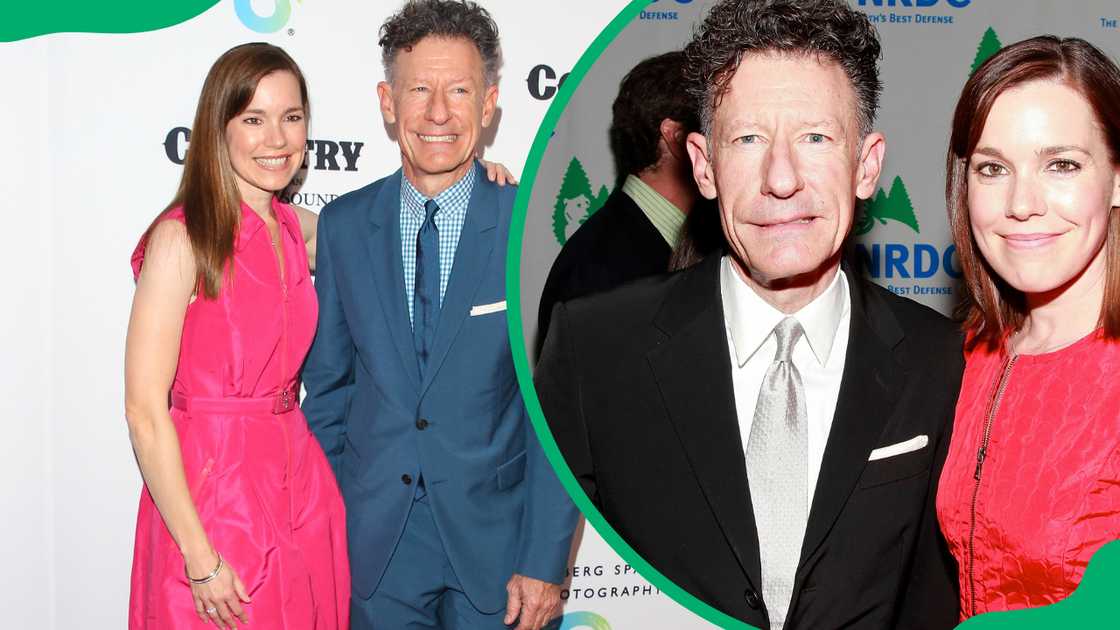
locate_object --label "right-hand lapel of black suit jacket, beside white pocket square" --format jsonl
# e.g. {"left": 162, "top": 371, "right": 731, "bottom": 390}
{"left": 801, "top": 271, "right": 907, "bottom": 566}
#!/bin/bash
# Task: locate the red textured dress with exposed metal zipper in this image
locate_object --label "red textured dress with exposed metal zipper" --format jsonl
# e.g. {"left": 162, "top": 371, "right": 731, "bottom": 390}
{"left": 937, "top": 331, "right": 1120, "bottom": 619}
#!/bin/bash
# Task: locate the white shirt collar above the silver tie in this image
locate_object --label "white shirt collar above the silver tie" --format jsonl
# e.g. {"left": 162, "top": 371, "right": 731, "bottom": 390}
{"left": 719, "top": 256, "right": 850, "bottom": 368}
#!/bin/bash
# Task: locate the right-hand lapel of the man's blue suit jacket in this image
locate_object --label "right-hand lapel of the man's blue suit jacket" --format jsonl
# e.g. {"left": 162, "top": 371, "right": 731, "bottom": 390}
{"left": 421, "top": 165, "right": 498, "bottom": 396}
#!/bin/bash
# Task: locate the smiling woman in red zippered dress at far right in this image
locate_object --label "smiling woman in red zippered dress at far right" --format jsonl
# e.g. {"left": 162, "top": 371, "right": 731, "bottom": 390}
{"left": 937, "top": 36, "right": 1120, "bottom": 619}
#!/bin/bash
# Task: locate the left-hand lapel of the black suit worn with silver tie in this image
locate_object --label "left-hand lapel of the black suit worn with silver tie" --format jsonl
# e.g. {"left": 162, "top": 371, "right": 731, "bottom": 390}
{"left": 647, "top": 254, "right": 762, "bottom": 587}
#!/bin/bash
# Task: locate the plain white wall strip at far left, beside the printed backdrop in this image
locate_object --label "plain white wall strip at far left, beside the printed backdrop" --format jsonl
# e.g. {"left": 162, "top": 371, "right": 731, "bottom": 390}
{"left": 0, "top": 41, "right": 52, "bottom": 628}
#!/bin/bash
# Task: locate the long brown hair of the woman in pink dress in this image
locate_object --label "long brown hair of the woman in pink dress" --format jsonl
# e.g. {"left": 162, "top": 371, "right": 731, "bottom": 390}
{"left": 148, "top": 43, "right": 310, "bottom": 298}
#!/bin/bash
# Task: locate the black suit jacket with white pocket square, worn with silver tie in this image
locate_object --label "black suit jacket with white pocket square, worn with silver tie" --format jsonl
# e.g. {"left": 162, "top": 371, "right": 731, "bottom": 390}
{"left": 535, "top": 256, "right": 963, "bottom": 630}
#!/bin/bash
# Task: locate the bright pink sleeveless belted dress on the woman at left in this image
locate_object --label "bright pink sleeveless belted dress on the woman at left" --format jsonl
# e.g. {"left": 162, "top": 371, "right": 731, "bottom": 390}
{"left": 129, "top": 198, "right": 351, "bottom": 630}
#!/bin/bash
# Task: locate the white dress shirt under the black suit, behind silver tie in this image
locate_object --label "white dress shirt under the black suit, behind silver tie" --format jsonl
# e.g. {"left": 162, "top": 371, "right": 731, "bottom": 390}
{"left": 719, "top": 256, "right": 851, "bottom": 513}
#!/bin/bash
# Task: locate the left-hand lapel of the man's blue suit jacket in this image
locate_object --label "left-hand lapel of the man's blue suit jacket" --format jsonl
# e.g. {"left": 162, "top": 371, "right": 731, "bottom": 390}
{"left": 366, "top": 170, "right": 420, "bottom": 390}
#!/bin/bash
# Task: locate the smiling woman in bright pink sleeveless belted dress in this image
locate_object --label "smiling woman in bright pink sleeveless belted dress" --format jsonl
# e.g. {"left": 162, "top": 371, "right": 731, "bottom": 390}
{"left": 125, "top": 44, "right": 349, "bottom": 630}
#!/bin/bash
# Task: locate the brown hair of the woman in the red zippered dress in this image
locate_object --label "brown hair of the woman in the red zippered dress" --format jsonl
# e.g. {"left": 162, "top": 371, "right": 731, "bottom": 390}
{"left": 945, "top": 35, "right": 1120, "bottom": 349}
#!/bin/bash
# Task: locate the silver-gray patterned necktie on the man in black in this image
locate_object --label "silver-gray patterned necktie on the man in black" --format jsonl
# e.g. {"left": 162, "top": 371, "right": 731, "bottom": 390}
{"left": 746, "top": 317, "right": 809, "bottom": 630}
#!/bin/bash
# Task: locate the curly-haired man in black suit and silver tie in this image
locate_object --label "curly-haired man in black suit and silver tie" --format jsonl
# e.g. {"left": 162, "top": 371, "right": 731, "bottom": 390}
{"left": 536, "top": 0, "right": 962, "bottom": 630}
